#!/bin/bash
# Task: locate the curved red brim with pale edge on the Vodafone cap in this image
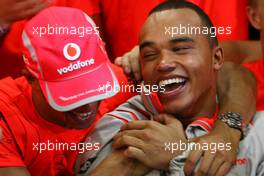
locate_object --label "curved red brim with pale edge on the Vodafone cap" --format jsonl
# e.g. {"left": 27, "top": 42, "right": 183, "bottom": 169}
{"left": 39, "top": 63, "right": 119, "bottom": 111}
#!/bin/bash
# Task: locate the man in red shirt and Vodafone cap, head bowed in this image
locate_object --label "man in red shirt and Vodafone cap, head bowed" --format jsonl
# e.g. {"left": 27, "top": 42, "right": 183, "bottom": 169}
{"left": 0, "top": 7, "right": 134, "bottom": 176}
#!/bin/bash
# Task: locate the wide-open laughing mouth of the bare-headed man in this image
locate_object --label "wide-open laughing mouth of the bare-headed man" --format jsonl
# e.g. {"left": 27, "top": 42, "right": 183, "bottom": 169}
{"left": 159, "top": 77, "right": 188, "bottom": 93}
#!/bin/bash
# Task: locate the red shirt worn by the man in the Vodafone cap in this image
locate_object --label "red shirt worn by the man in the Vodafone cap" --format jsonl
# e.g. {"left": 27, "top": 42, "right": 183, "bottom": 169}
{"left": 0, "top": 67, "right": 133, "bottom": 176}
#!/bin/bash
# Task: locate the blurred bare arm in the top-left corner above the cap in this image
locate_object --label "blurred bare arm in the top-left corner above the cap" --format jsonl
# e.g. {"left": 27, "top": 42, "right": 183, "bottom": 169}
{"left": 0, "top": 0, "right": 51, "bottom": 24}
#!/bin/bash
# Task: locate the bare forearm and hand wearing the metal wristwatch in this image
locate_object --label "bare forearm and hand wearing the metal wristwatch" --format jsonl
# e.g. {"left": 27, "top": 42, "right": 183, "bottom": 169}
{"left": 185, "top": 63, "right": 256, "bottom": 175}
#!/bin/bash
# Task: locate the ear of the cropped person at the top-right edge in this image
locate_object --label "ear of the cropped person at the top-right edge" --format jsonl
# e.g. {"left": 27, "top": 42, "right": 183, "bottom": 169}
{"left": 247, "top": 6, "right": 261, "bottom": 30}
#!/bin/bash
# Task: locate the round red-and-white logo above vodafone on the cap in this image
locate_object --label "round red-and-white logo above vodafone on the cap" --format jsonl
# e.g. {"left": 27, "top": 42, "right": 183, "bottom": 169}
{"left": 63, "top": 43, "right": 81, "bottom": 61}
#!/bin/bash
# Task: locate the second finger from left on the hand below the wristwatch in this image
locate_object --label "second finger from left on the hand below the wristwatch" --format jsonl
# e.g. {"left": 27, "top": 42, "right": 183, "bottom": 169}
{"left": 195, "top": 152, "right": 215, "bottom": 176}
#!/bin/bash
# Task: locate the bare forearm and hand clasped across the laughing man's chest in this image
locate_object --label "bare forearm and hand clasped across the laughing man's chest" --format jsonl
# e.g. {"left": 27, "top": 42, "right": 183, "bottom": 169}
{"left": 92, "top": 114, "right": 187, "bottom": 176}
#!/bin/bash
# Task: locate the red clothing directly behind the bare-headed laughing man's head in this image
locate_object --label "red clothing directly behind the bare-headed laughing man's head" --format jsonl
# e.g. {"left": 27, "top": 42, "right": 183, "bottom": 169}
{"left": 98, "top": 0, "right": 248, "bottom": 60}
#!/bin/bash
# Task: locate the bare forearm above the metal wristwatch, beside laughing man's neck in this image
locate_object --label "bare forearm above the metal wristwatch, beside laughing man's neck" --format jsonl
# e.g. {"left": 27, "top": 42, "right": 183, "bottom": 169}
{"left": 217, "top": 62, "right": 256, "bottom": 124}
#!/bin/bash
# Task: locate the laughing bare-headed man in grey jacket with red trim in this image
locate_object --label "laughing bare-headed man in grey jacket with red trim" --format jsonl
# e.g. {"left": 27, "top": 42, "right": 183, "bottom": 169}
{"left": 77, "top": 1, "right": 264, "bottom": 176}
